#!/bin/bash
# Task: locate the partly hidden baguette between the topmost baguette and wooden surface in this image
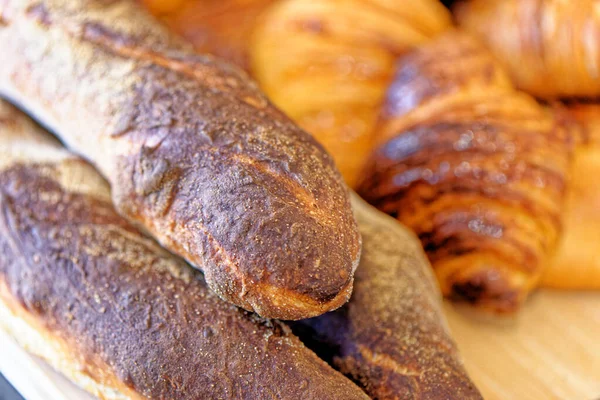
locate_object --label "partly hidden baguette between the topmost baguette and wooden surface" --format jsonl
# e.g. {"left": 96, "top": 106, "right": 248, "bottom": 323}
{"left": 292, "top": 196, "right": 482, "bottom": 400}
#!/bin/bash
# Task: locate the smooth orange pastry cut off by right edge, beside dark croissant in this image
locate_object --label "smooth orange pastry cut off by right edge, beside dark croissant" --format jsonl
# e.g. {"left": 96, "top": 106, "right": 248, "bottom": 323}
{"left": 541, "top": 103, "right": 600, "bottom": 289}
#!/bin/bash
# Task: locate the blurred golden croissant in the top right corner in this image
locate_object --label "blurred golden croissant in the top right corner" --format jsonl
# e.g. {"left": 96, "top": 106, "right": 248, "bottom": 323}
{"left": 454, "top": 0, "right": 600, "bottom": 98}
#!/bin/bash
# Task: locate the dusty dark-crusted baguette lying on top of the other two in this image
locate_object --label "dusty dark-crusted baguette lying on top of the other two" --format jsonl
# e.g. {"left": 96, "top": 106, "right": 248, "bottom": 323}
{"left": 0, "top": 0, "right": 360, "bottom": 319}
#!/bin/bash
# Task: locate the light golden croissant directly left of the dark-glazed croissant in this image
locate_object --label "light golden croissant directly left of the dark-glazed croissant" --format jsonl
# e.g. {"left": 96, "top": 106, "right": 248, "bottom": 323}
{"left": 250, "top": 0, "right": 450, "bottom": 186}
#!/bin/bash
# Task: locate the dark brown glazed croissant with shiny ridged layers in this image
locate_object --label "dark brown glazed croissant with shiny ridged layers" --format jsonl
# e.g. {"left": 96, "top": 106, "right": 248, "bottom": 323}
{"left": 359, "top": 32, "right": 570, "bottom": 311}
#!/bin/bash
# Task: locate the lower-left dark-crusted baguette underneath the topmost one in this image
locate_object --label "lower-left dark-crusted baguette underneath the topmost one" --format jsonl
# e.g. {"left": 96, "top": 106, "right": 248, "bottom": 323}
{"left": 0, "top": 103, "right": 368, "bottom": 400}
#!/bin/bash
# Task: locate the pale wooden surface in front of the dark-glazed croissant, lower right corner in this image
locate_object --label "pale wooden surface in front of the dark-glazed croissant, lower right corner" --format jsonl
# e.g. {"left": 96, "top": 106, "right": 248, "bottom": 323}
{"left": 445, "top": 290, "right": 600, "bottom": 400}
